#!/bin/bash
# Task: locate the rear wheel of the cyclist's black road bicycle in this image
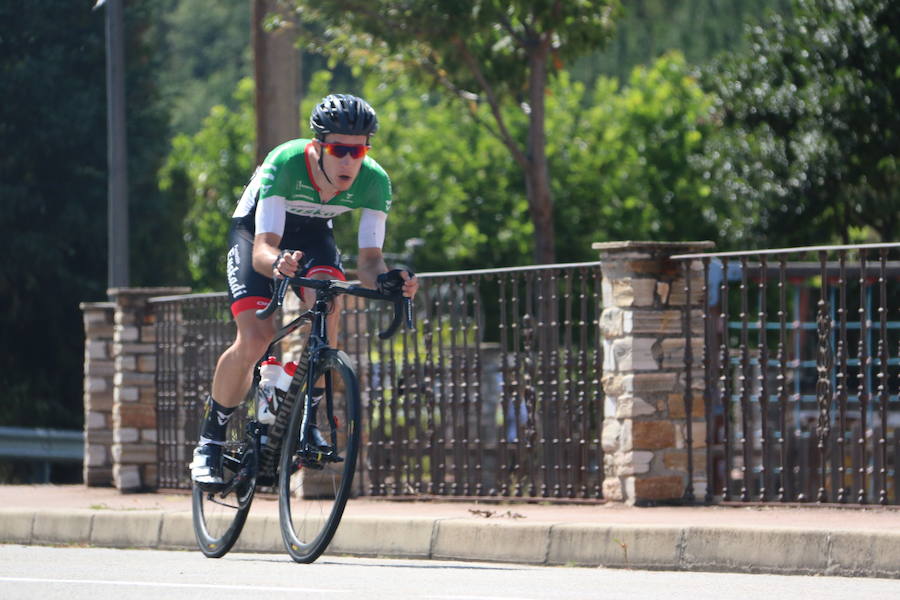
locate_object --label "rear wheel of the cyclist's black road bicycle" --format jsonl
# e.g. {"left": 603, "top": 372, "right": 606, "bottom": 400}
{"left": 191, "top": 419, "right": 259, "bottom": 558}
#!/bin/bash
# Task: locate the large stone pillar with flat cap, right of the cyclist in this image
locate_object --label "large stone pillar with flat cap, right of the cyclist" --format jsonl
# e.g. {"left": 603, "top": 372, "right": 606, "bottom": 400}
{"left": 593, "top": 242, "right": 714, "bottom": 504}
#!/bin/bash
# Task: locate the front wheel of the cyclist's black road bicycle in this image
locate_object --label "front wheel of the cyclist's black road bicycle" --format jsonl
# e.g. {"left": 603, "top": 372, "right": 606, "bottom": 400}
{"left": 278, "top": 350, "right": 361, "bottom": 563}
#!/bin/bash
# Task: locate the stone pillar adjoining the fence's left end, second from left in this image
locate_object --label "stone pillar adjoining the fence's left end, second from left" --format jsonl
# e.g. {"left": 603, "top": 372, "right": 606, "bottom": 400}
{"left": 109, "top": 288, "right": 190, "bottom": 492}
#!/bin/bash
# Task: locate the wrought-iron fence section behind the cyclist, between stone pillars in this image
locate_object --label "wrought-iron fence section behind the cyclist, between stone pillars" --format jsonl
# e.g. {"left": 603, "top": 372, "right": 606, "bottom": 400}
{"left": 154, "top": 262, "right": 603, "bottom": 501}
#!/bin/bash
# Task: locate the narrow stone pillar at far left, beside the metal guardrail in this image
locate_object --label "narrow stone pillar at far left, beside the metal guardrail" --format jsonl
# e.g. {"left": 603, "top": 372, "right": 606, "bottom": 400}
{"left": 80, "top": 302, "right": 115, "bottom": 486}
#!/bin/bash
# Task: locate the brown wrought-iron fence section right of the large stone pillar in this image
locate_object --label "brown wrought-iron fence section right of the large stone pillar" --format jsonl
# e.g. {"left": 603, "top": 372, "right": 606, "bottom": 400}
{"left": 674, "top": 244, "right": 900, "bottom": 504}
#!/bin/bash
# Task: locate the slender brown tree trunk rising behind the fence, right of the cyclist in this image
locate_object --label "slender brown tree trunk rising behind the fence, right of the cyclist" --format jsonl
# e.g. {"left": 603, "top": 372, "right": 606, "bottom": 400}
{"left": 525, "top": 43, "right": 556, "bottom": 264}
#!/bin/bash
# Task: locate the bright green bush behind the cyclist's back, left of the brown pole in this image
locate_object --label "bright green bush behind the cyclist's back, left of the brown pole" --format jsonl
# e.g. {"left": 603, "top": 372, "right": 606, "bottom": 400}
{"left": 160, "top": 79, "right": 255, "bottom": 290}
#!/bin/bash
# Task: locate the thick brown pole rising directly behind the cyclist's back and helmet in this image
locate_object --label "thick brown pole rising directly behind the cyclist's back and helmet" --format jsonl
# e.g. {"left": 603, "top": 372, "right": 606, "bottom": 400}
{"left": 250, "top": 0, "right": 300, "bottom": 164}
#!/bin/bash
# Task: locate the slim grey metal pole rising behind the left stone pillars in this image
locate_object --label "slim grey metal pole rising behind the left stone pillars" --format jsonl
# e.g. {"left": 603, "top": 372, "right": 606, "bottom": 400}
{"left": 94, "top": 0, "right": 129, "bottom": 288}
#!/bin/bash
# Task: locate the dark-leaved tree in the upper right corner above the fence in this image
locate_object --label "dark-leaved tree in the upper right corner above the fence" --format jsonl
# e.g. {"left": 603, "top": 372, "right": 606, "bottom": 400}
{"left": 704, "top": 0, "right": 900, "bottom": 246}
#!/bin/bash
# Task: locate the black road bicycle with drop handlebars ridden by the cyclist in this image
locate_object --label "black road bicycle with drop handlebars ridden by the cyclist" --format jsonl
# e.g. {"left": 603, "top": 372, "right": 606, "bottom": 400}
{"left": 192, "top": 277, "right": 413, "bottom": 563}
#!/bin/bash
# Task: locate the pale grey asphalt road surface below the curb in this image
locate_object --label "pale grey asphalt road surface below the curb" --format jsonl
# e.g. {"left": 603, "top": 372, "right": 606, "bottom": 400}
{"left": 0, "top": 545, "right": 900, "bottom": 600}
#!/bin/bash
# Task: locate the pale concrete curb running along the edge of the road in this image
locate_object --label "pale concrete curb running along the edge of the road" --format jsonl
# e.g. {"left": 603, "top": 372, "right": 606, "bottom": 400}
{"left": 0, "top": 508, "right": 900, "bottom": 579}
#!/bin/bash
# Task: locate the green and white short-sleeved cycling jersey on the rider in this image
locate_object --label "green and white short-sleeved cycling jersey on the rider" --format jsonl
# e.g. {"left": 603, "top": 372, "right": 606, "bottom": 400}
{"left": 232, "top": 139, "right": 391, "bottom": 248}
